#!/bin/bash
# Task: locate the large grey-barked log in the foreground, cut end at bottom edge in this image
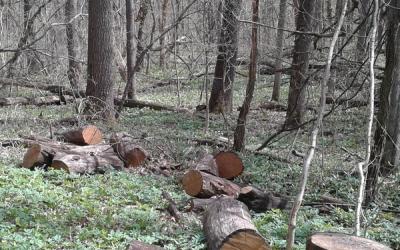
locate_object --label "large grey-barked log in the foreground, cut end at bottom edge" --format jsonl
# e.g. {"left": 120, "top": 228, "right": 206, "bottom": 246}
{"left": 203, "top": 197, "right": 270, "bottom": 250}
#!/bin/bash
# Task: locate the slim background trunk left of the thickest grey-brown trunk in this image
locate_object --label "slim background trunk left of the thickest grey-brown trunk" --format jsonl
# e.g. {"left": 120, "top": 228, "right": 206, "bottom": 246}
{"left": 65, "top": 0, "right": 80, "bottom": 90}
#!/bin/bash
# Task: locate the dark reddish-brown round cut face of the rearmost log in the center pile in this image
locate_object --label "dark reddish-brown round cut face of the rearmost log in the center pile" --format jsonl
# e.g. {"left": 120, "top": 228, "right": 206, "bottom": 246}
{"left": 214, "top": 152, "right": 244, "bottom": 179}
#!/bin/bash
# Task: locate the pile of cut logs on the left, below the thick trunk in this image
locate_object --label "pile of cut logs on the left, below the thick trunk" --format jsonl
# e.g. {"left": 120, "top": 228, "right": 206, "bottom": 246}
{"left": 21, "top": 126, "right": 148, "bottom": 174}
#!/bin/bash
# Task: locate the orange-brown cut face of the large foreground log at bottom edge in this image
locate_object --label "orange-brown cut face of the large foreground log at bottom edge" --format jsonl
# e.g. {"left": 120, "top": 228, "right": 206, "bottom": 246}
{"left": 220, "top": 230, "right": 271, "bottom": 250}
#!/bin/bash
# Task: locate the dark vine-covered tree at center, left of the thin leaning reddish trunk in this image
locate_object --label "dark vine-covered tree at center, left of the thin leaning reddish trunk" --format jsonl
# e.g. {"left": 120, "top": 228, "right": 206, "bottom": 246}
{"left": 209, "top": 0, "right": 241, "bottom": 113}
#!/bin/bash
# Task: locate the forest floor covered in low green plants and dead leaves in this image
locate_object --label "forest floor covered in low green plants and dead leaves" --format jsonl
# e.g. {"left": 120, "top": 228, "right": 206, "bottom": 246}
{"left": 0, "top": 71, "right": 400, "bottom": 249}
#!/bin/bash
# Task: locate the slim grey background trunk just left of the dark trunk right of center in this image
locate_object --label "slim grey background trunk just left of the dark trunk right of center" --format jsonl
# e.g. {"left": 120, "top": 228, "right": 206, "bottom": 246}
{"left": 272, "top": 0, "right": 287, "bottom": 102}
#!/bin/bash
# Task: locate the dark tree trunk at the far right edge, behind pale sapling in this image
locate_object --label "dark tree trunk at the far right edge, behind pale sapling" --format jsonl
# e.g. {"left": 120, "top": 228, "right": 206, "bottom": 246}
{"left": 366, "top": 1, "right": 400, "bottom": 202}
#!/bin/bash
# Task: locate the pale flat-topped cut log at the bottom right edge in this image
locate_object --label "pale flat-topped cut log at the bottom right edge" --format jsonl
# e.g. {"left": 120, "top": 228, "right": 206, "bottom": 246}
{"left": 306, "top": 233, "right": 391, "bottom": 250}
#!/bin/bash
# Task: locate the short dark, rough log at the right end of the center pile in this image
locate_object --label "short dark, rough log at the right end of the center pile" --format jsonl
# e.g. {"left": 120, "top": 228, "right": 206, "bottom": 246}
{"left": 238, "top": 186, "right": 288, "bottom": 213}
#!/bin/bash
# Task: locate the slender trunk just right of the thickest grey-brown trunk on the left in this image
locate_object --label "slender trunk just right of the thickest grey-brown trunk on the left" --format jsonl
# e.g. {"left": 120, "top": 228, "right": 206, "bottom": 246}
{"left": 125, "top": 0, "right": 136, "bottom": 100}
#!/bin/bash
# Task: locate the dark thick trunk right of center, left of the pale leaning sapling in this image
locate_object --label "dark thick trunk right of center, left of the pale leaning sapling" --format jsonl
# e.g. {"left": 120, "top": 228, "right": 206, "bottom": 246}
{"left": 285, "top": 0, "right": 316, "bottom": 128}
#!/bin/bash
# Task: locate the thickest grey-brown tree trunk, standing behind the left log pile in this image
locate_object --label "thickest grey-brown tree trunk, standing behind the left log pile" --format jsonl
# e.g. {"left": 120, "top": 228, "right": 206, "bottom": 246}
{"left": 86, "top": 0, "right": 114, "bottom": 120}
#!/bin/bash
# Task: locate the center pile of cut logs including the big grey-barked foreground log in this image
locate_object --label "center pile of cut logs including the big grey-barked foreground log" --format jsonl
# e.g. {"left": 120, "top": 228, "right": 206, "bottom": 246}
{"left": 182, "top": 152, "right": 287, "bottom": 250}
